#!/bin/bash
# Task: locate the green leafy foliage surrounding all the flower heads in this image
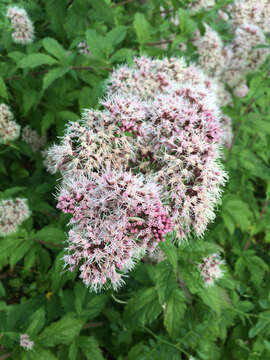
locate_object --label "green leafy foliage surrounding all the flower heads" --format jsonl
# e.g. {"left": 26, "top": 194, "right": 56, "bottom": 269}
{"left": 0, "top": 0, "right": 270, "bottom": 360}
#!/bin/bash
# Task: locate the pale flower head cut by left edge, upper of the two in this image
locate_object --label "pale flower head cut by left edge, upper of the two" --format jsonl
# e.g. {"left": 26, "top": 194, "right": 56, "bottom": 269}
{"left": 0, "top": 104, "right": 20, "bottom": 144}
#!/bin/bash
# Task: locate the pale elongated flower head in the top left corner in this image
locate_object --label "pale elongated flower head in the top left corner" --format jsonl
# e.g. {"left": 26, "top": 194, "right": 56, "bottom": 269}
{"left": 7, "top": 6, "right": 35, "bottom": 45}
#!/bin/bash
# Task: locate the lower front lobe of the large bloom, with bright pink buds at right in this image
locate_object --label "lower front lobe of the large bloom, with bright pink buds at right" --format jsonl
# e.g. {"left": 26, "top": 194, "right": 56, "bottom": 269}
{"left": 57, "top": 170, "right": 173, "bottom": 291}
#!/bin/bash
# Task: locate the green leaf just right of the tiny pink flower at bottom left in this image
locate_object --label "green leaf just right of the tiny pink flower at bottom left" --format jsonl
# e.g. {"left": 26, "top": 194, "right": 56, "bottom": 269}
{"left": 38, "top": 315, "right": 84, "bottom": 347}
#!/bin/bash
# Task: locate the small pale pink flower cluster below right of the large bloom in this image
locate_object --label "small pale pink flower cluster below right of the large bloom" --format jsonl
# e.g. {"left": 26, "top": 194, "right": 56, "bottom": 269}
{"left": 197, "top": 253, "right": 225, "bottom": 286}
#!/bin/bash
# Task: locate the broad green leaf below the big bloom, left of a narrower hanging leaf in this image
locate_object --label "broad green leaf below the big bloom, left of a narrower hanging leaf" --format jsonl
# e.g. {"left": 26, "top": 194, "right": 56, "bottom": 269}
{"left": 124, "top": 287, "right": 162, "bottom": 326}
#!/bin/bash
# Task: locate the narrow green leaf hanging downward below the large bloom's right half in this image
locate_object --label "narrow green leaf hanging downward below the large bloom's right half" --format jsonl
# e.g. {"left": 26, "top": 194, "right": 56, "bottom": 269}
{"left": 164, "top": 288, "right": 186, "bottom": 338}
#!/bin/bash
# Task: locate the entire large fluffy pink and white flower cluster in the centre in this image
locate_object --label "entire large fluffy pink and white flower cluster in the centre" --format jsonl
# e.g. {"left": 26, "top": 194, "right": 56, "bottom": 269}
{"left": 46, "top": 57, "right": 226, "bottom": 290}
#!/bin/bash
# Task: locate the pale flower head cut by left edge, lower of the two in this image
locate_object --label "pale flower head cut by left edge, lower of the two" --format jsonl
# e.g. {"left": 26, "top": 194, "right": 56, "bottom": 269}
{"left": 0, "top": 198, "right": 30, "bottom": 236}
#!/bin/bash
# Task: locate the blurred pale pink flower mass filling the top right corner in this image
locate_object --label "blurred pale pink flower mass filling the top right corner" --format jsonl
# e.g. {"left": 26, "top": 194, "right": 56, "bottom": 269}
{"left": 195, "top": 0, "right": 270, "bottom": 99}
